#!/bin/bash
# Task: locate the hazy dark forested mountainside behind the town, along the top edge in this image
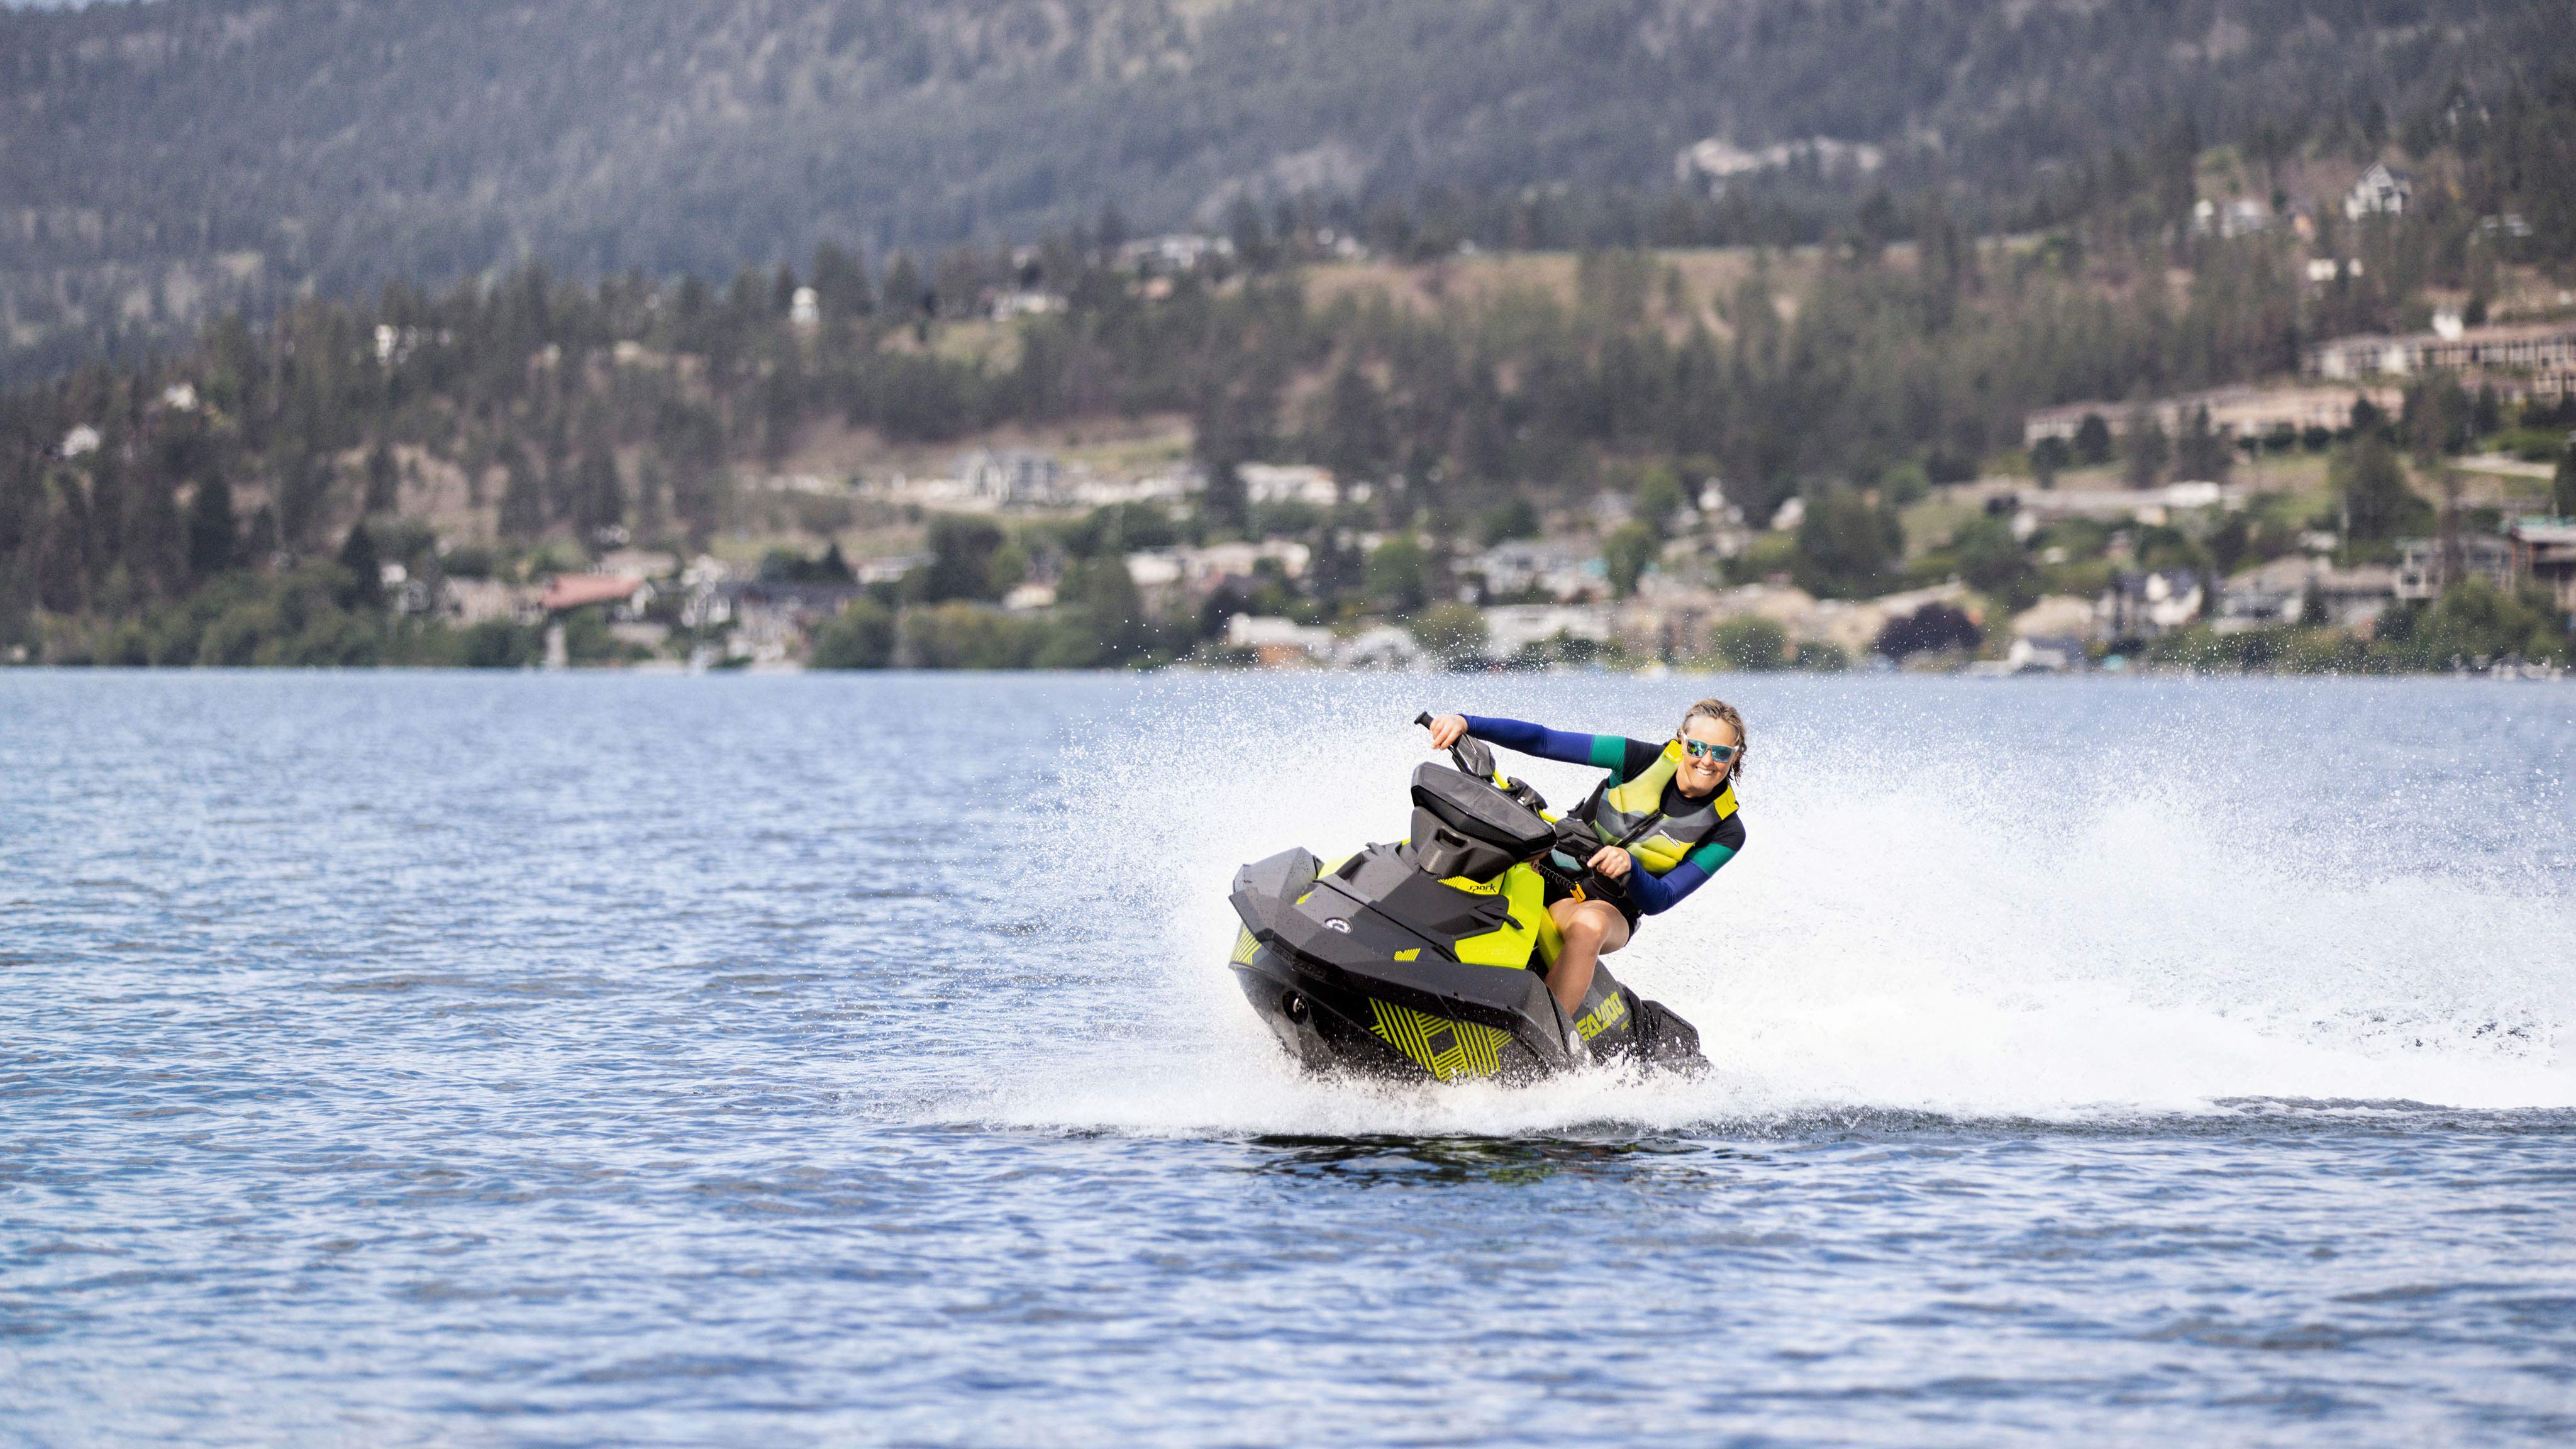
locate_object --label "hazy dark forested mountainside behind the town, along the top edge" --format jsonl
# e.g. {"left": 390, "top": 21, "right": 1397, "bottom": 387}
{"left": 0, "top": 0, "right": 2571, "bottom": 377}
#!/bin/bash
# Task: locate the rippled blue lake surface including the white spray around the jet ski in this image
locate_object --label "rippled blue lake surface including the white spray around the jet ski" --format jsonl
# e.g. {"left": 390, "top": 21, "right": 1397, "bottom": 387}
{"left": 0, "top": 670, "right": 2576, "bottom": 1446}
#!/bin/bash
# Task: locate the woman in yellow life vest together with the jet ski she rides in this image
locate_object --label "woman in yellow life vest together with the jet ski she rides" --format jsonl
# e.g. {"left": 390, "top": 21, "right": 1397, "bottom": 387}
{"left": 1231, "top": 699, "right": 1744, "bottom": 1083}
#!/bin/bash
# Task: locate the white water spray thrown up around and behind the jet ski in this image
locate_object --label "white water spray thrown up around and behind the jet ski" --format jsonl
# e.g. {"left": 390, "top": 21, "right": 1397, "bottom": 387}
{"left": 989, "top": 680, "right": 2576, "bottom": 1135}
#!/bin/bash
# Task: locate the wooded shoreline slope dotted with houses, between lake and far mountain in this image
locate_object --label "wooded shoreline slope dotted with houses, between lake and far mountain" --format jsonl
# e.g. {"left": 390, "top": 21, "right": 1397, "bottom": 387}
{"left": 0, "top": 145, "right": 2576, "bottom": 678}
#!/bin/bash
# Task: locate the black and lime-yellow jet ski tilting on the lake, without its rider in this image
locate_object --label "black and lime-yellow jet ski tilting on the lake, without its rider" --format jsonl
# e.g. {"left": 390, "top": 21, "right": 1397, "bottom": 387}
{"left": 1229, "top": 714, "right": 1708, "bottom": 1083}
